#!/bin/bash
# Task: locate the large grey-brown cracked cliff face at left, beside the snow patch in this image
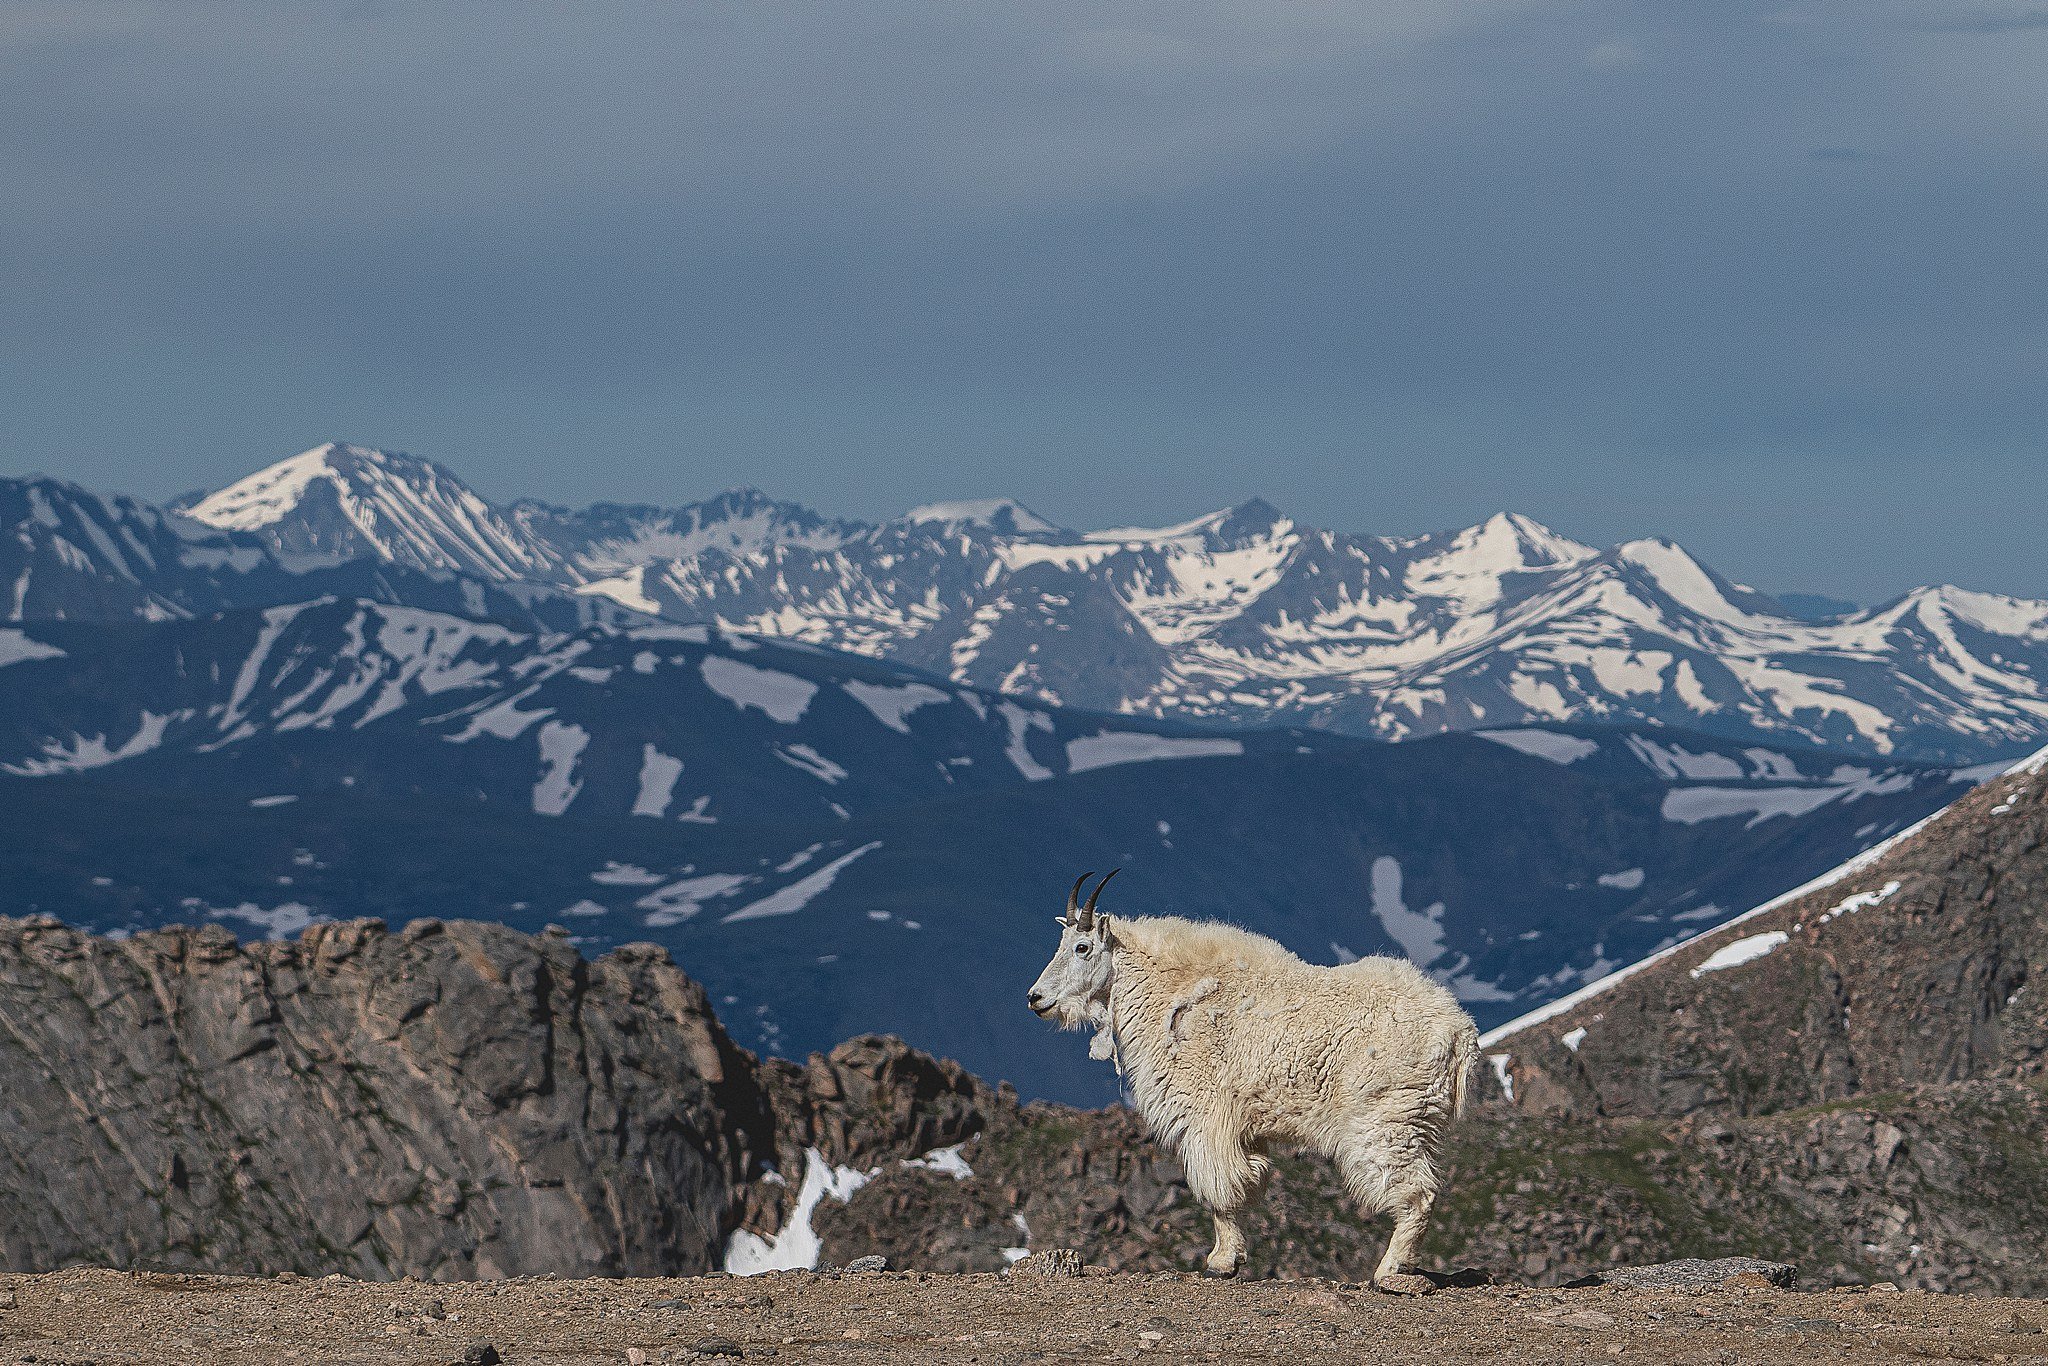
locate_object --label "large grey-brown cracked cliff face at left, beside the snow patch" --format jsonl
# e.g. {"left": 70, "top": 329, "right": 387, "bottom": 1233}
{"left": 0, "top": 920, "right": 772, "bottom": 1278}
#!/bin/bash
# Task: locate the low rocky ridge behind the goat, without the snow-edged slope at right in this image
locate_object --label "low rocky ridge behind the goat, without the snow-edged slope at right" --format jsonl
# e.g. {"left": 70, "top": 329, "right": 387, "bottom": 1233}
{"left": 0, "top": 901, "right": 2048, "bottom": 1294}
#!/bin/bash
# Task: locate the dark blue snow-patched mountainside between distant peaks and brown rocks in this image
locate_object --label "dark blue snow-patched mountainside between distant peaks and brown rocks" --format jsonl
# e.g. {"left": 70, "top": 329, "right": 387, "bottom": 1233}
{"left": 0, "top": 602, "right": 1970, "bottom": 1100}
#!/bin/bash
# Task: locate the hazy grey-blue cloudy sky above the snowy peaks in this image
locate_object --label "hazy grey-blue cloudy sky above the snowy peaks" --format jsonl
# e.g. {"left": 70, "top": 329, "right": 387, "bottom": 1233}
{"left": 0, "top": 0, "right": 2048, "bottom": 600}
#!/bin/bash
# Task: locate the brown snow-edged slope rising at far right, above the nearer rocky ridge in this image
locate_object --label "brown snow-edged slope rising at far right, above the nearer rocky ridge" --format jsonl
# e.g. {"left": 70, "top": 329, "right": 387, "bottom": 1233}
{"left": 1489, "top": 756, "right": 2048, "bottom": 1114}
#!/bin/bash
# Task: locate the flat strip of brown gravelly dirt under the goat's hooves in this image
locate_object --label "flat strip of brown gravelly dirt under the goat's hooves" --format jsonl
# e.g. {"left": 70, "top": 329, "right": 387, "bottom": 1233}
{"left": 0, "top": 1270, "right": 2048, "bottom": 1366}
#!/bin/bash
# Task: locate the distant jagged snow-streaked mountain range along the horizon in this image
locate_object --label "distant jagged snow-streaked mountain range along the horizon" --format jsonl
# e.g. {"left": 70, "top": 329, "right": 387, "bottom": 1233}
{"left": 0, "top": 444, "right": 2048, "bottom": 762}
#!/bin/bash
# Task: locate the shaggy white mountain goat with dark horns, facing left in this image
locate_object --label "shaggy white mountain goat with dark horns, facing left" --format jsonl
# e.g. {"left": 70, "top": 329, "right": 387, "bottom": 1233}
{"left": 1028, "top": 872, "right": 1479, "bottom": 1294}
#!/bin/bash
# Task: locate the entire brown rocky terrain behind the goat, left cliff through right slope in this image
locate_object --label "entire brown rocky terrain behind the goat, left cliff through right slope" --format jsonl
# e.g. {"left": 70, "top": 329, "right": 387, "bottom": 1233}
{"left": 0, "top": 753, "right": 2048, "bottom": 1296}
